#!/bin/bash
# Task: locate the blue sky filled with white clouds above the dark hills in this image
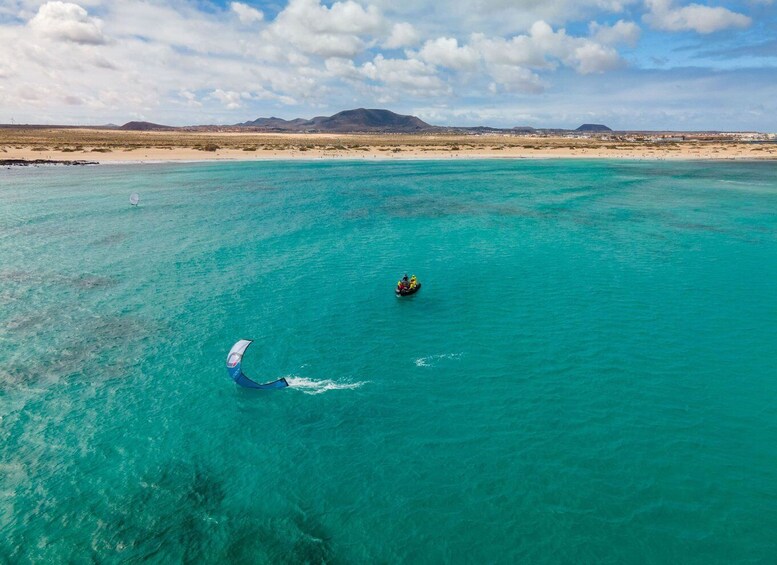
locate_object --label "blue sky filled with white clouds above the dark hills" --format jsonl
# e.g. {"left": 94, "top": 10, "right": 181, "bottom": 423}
{"left": 0, "top": 0, "right": 777, "bottom": 132}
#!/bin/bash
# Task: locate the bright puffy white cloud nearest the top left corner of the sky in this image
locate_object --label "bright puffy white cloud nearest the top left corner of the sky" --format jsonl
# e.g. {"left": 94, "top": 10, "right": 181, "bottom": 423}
{"left": 29, "top": 1, "right": 106, "bottom": 45}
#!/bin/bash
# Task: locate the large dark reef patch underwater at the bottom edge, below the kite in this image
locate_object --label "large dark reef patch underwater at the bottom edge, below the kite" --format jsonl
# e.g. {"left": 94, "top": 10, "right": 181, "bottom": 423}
{"left": 93, "top": 460, "right": 334, "bottom": 564}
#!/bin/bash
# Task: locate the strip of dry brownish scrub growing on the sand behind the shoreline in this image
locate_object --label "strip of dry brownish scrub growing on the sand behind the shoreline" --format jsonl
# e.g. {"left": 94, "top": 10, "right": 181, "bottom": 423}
{"left": 0, "top": 128, "right": 777, "bottom": 158}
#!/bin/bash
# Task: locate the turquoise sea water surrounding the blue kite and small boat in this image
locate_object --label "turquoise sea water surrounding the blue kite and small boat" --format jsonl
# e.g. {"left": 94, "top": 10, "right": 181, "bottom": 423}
{"left": 0, "top": 160, "right": 777, "bottom": 564}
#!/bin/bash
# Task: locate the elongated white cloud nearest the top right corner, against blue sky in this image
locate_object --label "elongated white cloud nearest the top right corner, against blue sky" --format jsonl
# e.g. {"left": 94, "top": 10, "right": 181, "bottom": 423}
{"left": 643, "top": 0, "right": 751, "bottom": 33}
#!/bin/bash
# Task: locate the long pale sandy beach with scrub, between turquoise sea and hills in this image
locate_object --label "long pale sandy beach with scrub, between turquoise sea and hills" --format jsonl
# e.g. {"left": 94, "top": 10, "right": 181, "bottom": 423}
{"left": 0, "top": 128, "right": 777, "bottom": 163}
